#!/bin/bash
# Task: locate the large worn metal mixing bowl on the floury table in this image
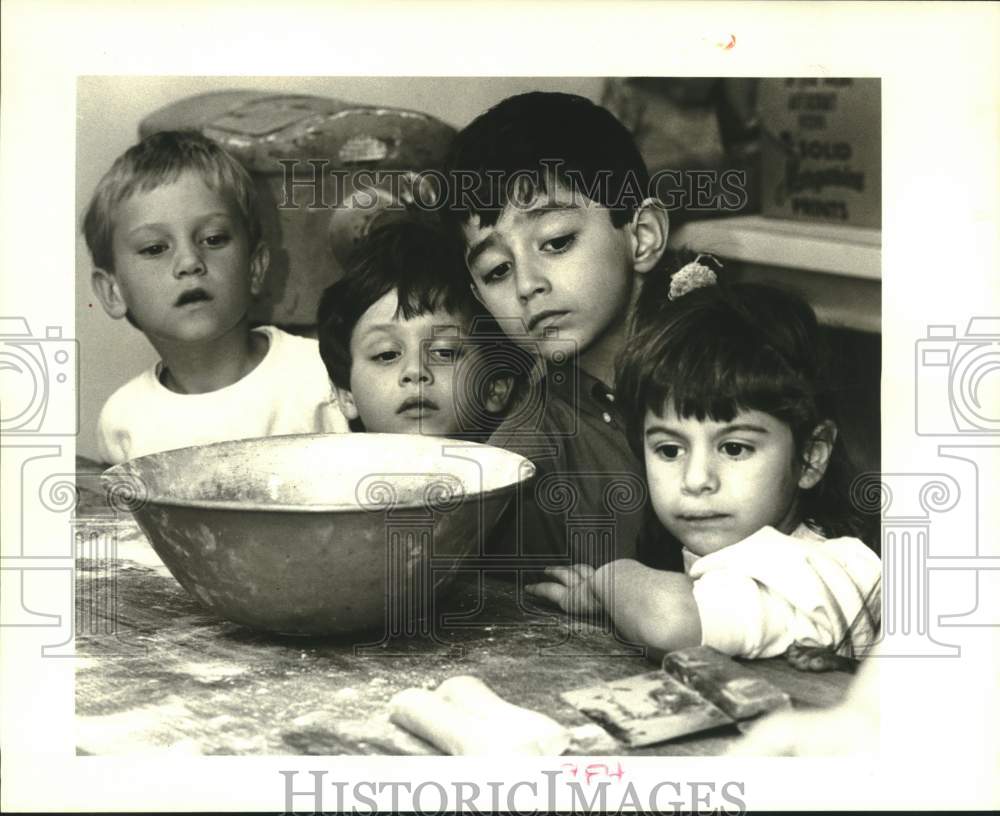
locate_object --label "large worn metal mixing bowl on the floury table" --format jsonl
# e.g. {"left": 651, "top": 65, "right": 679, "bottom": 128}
{"left": 104, "top": 433, "right": 534, "bottom": 635}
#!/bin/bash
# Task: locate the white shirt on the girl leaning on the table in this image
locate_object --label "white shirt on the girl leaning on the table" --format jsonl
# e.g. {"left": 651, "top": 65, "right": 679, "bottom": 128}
{"left": 684, "top": 524, "right": 882, "bottom": 657}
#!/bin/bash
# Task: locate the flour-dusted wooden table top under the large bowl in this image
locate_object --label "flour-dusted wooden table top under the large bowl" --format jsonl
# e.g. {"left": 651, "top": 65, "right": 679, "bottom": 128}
{"left": 76, "top": 456, "right": 851, "bottom": 755}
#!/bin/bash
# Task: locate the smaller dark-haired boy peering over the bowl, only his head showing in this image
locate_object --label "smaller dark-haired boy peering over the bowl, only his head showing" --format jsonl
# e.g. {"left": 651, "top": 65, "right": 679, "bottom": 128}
{"left": 317, "top": 220, "right": 518, "bottom": 439}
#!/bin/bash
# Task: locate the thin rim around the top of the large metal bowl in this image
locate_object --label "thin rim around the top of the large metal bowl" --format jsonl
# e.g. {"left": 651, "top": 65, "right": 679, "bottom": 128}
{"left": 101, "top": 432, "right": 538, "bottom": 513}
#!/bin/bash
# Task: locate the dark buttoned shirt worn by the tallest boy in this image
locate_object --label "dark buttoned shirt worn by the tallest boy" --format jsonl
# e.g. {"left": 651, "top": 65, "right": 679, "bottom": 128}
{"left": 478, "top": 361, "right": 681, "bottom": 569}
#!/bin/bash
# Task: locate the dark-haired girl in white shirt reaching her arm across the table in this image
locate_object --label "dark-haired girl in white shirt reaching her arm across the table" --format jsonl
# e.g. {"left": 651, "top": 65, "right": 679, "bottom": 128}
{"left": 532, "top": 264, "right": 882, "bottom": 668}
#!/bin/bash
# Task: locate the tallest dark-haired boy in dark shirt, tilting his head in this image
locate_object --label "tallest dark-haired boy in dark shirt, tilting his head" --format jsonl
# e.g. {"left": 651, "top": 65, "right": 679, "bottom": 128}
{"left": 449, "top": 93, "right": 668, "bottom": 566}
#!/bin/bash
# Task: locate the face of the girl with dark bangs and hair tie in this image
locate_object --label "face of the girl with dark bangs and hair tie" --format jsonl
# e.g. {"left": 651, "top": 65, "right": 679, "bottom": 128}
{"left": 643, "top": 400, "right": 811, "bottom": 555}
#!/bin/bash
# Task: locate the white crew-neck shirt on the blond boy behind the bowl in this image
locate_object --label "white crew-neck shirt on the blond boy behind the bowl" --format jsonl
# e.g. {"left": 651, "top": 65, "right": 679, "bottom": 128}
{"left": 97, "top": 326, "right": 349, "bottom": 464}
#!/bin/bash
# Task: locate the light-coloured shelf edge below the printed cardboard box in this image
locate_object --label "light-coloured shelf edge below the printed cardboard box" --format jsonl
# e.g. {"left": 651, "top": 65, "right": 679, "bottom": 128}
{"left": 670, "top": 215, "right": 882, "bottom": 281}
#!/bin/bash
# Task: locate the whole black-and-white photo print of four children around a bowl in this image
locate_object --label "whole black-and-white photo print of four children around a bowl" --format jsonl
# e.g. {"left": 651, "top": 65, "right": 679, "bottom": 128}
{"left": 70, "top": 77, "right": 881, "bottom": 755}
